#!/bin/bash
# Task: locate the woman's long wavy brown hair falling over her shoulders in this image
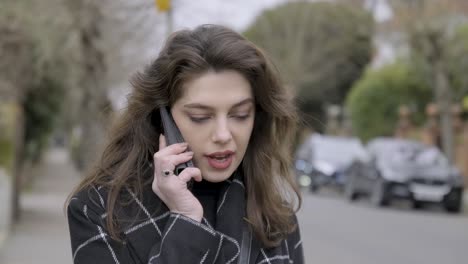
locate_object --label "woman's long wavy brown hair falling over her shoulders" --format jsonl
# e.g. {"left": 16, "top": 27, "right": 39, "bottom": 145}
{"left": 72, "top": 25, "right": 301, "bottom": 247}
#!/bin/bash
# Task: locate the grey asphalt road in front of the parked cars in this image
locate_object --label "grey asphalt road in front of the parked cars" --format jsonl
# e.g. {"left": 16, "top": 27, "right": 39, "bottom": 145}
{"left": 299, "top": 192, "right": 468, "bottom": 264}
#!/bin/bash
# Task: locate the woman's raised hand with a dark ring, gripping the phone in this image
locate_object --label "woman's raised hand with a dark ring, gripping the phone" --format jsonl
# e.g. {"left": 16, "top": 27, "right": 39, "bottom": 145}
{"left": 152, "top": 135, "right": 203, "bottom": 222}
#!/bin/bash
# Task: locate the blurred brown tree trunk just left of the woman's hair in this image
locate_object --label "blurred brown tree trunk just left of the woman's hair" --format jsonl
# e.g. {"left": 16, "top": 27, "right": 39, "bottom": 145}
{"left": 70, "top": 0, "right": 110, "bottom": 170}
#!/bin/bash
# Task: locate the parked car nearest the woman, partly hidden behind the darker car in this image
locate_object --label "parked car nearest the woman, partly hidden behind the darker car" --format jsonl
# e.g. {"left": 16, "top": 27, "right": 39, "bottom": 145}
{"left": 295, "top": 133, "right": 366, "bottom": 192}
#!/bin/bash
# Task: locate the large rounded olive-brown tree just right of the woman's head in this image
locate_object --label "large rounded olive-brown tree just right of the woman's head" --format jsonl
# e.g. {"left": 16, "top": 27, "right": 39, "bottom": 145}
{"left": 244, "top": 1, "right": 374, "bottom": 130}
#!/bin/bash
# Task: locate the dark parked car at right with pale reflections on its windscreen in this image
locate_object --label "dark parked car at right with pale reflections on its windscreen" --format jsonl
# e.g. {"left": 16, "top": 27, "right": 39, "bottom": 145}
{"left": 345, "top": 138, "right": 463, "bottom": 212}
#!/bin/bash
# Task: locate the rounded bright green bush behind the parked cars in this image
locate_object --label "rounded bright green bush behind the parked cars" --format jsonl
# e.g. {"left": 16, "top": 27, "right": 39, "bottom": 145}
{"left": 346, "top": 62, "right": 432, "bottom": 141}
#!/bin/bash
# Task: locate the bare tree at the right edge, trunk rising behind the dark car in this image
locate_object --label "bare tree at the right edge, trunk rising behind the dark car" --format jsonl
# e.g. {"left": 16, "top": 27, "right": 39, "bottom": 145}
{"left": 390, "top": 0, "right": 468, "bottom": 162}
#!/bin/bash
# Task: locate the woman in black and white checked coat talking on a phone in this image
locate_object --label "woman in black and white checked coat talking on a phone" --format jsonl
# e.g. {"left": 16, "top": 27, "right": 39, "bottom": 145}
{"left": 68, "top": 25, "right": 303, "bottom": 264}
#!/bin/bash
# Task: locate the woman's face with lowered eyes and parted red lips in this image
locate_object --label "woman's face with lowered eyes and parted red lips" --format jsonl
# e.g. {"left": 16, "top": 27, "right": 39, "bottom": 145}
{"left": 171, "top": 70, "right": 255, "bottom": 182}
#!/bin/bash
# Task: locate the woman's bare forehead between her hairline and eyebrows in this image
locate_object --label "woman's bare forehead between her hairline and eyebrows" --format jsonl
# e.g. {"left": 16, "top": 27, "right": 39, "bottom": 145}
{"left": 176, "top": 70, "right": 253, "bottom": 107}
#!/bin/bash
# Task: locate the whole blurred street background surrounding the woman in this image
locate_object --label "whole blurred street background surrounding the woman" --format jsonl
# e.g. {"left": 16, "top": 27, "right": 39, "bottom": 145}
{"left": 0, "top": 0, "right": 468, "bottom": 264}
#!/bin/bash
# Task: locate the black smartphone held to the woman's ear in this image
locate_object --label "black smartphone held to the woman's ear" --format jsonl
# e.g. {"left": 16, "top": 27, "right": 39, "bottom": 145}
{"left": 159, "top": 107, "right": 193, "bottom": 176}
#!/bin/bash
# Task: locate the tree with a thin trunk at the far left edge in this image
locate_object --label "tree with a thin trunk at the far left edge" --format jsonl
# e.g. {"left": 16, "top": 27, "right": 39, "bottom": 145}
{"left": 0, "top": 0, "right": 81, "bottom": 219}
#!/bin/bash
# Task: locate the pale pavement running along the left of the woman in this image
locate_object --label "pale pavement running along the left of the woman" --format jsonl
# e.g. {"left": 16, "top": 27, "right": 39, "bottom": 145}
{"left": 0, "top": 149, "right": 80, "bottom": 264}
